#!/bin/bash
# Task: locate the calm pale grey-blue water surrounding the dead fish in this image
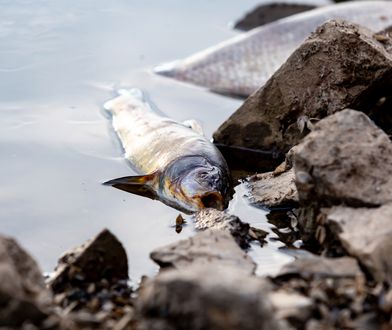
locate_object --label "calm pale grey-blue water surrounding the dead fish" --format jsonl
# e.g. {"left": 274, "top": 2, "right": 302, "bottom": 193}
{"left": 0, "top": 0, "right": 289, "bottom": 279}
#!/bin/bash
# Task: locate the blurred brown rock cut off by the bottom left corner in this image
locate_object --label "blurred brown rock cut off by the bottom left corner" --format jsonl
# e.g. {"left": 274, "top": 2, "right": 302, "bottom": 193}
{"left": 0, "top": 235, "right": 50, "bottom": 326}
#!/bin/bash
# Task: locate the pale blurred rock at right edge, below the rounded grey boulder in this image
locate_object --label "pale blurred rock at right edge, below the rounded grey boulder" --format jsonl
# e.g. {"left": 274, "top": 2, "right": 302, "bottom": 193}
{"left": 325, "top": 204, "right": 392, "bottom": 285}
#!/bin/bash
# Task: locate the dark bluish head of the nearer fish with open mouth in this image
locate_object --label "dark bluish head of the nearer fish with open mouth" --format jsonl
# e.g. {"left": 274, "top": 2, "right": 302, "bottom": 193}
{"left": 163, "top": 156, "right": 232, "bottom": 213}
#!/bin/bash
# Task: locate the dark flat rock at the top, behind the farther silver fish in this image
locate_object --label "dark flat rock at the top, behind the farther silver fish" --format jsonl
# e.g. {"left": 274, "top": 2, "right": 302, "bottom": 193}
{"left": 234, "top": 2, "right": 316, "bottom": 31}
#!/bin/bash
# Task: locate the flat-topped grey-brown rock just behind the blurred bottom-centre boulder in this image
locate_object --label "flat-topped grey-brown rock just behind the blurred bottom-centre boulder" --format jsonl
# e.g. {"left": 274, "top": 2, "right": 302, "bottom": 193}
{"left": 150, "top": 230, "right": 256, "bottom": 274}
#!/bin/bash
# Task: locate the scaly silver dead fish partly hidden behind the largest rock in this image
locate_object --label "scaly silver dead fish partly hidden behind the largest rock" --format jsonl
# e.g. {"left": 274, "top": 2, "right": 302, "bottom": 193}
{"left": 155, "top": 1, "right": 392, "bottom": 96}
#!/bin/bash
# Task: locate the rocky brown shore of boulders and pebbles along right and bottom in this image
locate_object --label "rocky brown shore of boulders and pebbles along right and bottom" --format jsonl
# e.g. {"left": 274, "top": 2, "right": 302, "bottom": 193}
{"left": 0, "top": 15, "right": 392, "bottom": 330}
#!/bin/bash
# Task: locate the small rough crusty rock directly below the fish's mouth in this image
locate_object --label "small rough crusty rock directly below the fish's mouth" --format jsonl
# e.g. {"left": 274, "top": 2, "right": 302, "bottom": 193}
{"left": 194, "top": 209, "right": 267, "bottom": 248}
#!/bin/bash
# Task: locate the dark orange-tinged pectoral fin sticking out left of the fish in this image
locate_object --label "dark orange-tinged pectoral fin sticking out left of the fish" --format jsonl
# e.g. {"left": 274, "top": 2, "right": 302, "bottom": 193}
{"left": 103, "top": 173, "right": 158, "bottom": 199}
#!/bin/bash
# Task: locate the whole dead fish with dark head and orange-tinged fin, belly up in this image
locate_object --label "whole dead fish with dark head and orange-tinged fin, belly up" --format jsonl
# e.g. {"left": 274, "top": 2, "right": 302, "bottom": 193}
{"left": 104, "top": 89, "right": 233, "bottom": 213}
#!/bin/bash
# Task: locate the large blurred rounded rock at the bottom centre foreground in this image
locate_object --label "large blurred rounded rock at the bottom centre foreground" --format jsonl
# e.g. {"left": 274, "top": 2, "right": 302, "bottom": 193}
{"left": 137, "top": 266, "right": 286, "bottom": 330}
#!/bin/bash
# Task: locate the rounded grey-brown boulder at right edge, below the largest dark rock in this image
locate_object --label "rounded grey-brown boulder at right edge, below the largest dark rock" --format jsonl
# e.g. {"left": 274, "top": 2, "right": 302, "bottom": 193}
{"left": 294, "top": 110, "right": 392, "bottom": 207}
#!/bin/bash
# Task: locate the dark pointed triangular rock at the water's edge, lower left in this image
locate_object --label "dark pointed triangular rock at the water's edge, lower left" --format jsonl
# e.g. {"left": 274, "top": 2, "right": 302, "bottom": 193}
{"left": 49, "top": 229, "right": 128, "bottom": 293}
